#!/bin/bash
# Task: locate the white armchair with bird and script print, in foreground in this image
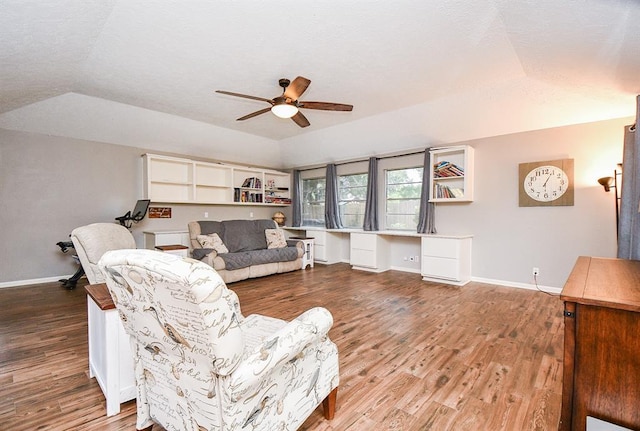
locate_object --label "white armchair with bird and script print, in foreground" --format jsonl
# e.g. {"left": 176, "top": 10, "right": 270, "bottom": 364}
{"left": 99, "top": 250, "right": 339, "bottom": 431}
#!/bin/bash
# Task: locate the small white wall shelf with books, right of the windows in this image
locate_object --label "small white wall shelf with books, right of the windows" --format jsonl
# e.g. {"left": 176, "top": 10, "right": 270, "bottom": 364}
{"left": 429, "top": 145, "right": 474, "bottom": 202}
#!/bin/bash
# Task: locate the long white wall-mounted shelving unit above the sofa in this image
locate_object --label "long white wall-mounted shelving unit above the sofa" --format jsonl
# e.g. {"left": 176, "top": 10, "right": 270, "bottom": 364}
{"left": 143, "top": 154, "right": 291, "bottom": 206}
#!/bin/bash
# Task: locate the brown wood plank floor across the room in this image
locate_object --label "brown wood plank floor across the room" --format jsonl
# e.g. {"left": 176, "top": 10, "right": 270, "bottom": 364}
{"left": 0, "top": 264, "right": 563, "bottom": 431}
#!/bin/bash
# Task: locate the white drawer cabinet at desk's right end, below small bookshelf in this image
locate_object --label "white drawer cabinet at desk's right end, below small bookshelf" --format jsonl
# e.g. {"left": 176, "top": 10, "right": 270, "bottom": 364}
{"left": 420, "top": 236, "right": 471, "bottom": 286}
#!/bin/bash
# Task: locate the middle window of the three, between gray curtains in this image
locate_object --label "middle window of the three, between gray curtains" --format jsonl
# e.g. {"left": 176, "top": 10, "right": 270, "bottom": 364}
{"left": 338, "top": 174, "right": 368, "bottom": 228}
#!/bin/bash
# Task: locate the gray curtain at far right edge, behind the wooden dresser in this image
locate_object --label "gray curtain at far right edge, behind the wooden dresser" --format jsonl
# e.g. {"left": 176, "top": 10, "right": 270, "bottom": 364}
{"left": 616, "top": 96, "right": 640, "bottom": 260}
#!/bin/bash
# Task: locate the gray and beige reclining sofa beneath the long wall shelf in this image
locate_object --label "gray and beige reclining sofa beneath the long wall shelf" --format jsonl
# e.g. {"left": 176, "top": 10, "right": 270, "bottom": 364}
{"left": 189, "top": 220, "right": 304, "bottom": 283}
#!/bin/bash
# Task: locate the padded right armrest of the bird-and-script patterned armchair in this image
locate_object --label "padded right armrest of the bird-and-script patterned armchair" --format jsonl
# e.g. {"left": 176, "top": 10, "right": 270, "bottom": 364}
{"left": 229, "top": 307, "right": 333, "bottom": 401}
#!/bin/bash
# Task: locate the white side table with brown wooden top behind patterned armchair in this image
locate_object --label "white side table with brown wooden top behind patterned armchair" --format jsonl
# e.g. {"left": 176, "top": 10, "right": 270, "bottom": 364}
{"left": 85, "top": 283, "right": 136, "bottom": 416}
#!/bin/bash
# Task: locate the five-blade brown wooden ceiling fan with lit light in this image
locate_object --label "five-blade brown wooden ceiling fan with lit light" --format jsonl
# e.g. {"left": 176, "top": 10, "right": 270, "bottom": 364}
{"left": 216, "top": 76, "right": 353, "bottom": 127}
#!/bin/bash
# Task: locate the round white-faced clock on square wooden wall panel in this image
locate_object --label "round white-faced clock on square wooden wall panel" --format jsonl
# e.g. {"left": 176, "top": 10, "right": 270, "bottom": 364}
{"left": 519, "top": 159, "right": 573, "bottom": 207}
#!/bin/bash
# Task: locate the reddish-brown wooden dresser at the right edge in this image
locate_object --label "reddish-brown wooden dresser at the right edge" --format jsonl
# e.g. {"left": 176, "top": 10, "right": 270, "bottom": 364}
{"left": 559, "top": 256, "right": 640, "bottom": 431}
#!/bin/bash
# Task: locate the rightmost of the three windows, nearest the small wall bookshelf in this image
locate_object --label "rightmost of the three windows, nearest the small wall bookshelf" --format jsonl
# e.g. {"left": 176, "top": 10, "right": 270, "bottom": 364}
{"left": 385, "top": 168, "right": 423, "bottom": 230}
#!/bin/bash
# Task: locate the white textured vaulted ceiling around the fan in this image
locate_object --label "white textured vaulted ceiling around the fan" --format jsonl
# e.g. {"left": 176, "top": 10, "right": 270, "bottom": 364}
{"left": 0, "top": 0, "right": 640, "bottom": 164}
